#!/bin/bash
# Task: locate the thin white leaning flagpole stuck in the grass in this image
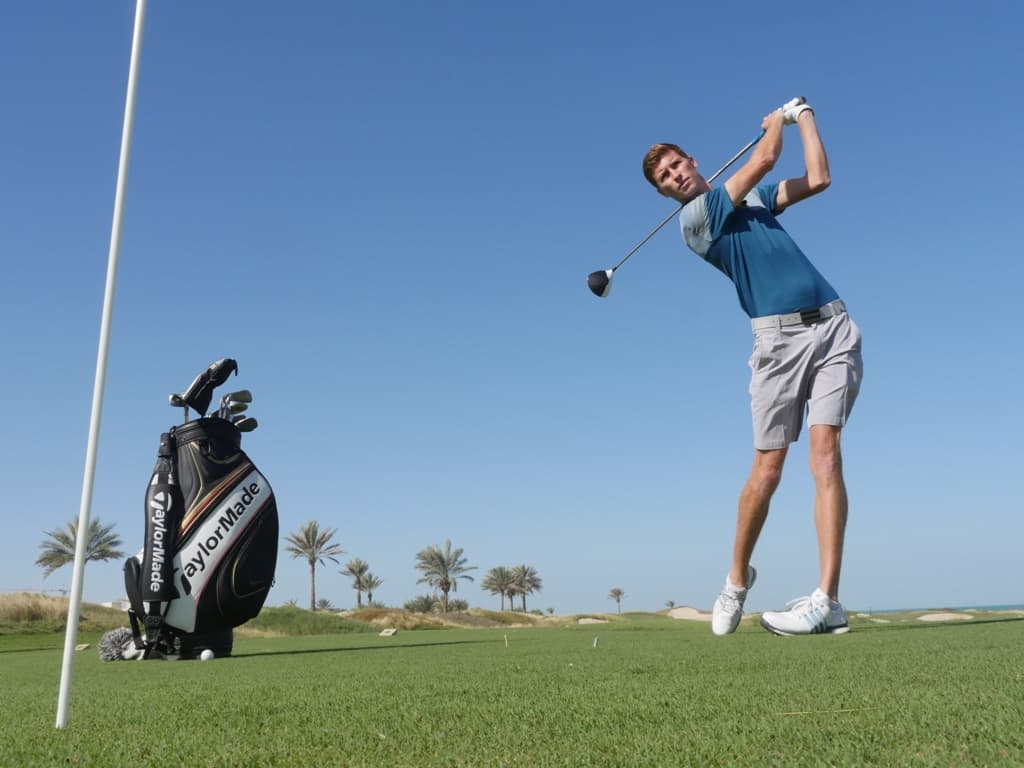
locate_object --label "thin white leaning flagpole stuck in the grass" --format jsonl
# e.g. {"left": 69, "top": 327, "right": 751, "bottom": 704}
{"left": 56, "top": 0, "right": 145, "bottom": 728}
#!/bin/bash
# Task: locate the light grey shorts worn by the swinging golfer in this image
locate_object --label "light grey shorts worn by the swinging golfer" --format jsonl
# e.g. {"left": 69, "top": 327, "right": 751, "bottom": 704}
{"left": 748, "top": 301, "right": 864, "bottom": 451}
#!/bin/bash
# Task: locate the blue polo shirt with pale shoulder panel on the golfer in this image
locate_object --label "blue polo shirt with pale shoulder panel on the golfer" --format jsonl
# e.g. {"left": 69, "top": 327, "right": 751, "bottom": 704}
{"left": 679, "top": 183, "right": 839, "bottom": 317}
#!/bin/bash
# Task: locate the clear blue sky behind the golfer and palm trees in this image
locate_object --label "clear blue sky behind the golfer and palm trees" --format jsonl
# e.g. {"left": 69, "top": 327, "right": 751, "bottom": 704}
{"left": 0, "top": 0, "right": 1024, "bottom": 613}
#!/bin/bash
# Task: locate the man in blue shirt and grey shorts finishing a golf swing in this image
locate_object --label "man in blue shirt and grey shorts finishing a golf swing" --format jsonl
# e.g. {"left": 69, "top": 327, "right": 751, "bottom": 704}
{"left": 643, "top": 99, "right": 863, "bottom": 635}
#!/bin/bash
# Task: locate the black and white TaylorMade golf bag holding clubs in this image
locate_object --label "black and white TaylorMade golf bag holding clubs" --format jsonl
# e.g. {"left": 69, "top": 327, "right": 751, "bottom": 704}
{"left": 124, "top": 359, "right": 278, "bottom": 658}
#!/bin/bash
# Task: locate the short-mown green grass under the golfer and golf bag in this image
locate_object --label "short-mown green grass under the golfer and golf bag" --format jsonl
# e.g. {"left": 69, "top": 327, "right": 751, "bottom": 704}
{"left": 0, "top": 614, "right": 1024, "bottom": 766}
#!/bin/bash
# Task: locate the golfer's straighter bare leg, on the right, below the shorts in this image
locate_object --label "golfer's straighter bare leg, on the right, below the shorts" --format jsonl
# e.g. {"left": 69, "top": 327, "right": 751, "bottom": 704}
{"left": 810, "top": 424, "right": 849, "bottom": 601}
